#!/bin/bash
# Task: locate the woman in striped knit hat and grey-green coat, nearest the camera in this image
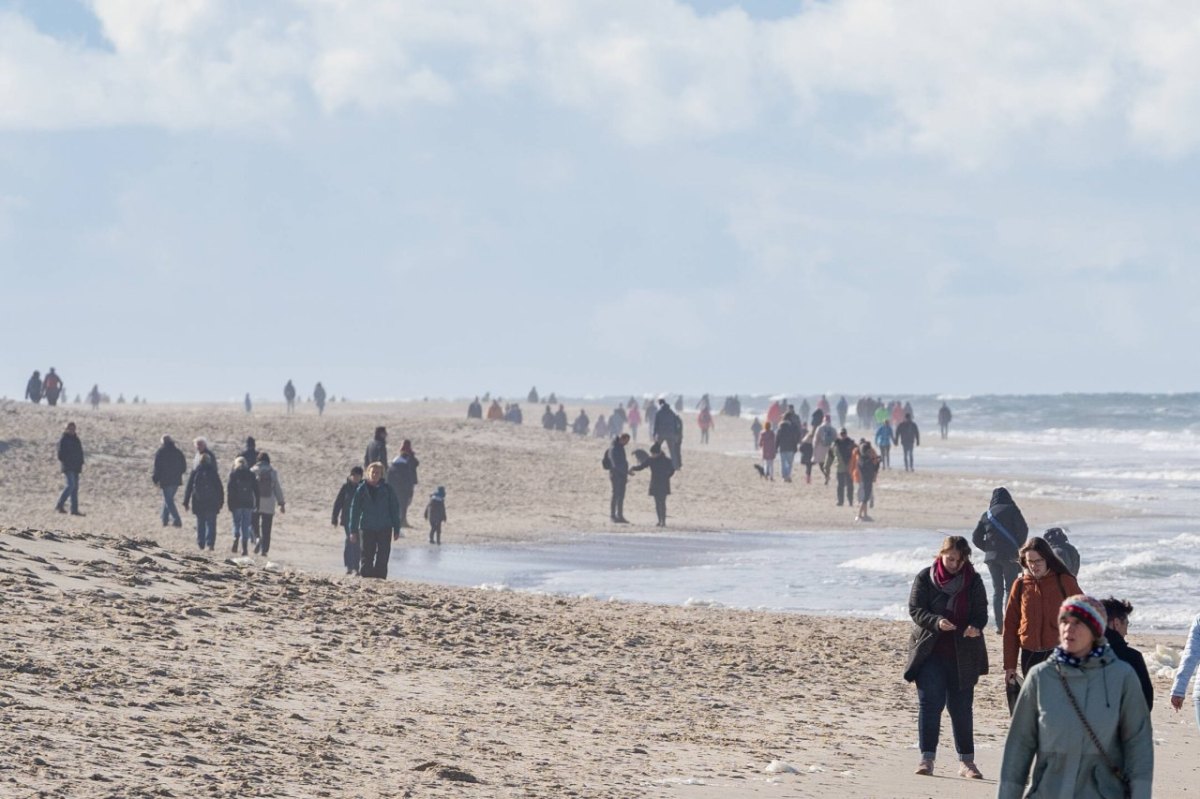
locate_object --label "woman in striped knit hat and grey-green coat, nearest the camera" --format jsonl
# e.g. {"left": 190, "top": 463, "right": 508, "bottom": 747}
{"left": 996, "top": 595, "right": 1154, "bottom": 799}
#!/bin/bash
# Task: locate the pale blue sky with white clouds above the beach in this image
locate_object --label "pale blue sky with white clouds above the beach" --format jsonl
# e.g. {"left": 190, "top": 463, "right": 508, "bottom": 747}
{"left": 0, "top": 0, "right": 1200, "bottom": 401}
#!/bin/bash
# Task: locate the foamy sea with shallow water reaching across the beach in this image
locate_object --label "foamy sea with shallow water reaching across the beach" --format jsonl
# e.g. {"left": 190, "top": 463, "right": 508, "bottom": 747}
{"left": 392, "top": 395, "right": 1200, "bottom": 631}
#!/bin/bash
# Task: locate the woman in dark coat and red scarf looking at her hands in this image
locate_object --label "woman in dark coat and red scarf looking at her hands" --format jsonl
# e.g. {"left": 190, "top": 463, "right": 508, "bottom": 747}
{"left": 904, "top": 535, "right": 988, "bottom": 780}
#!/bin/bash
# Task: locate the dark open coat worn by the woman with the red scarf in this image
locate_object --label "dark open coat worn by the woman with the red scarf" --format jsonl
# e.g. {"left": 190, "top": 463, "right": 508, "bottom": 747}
{"left": 904, "top": 566, "right": 988, "bottom": 686}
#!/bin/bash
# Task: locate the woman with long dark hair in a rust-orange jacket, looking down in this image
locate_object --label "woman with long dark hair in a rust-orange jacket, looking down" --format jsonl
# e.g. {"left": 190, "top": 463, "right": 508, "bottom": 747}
{"left": 1004, "top": 536, "right": 1080, "bottom": 684}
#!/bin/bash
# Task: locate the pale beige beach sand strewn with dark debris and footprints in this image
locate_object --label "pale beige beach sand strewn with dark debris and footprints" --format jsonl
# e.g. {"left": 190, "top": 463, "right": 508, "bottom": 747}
{"left": 0, "top": 403, "right": 1200, "bottom": 798}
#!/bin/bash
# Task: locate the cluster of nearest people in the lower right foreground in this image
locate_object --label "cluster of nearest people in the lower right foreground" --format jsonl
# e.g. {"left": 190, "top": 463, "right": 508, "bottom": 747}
{"left": 904, "top": 487, "right": 1200, "bottom": 799}
